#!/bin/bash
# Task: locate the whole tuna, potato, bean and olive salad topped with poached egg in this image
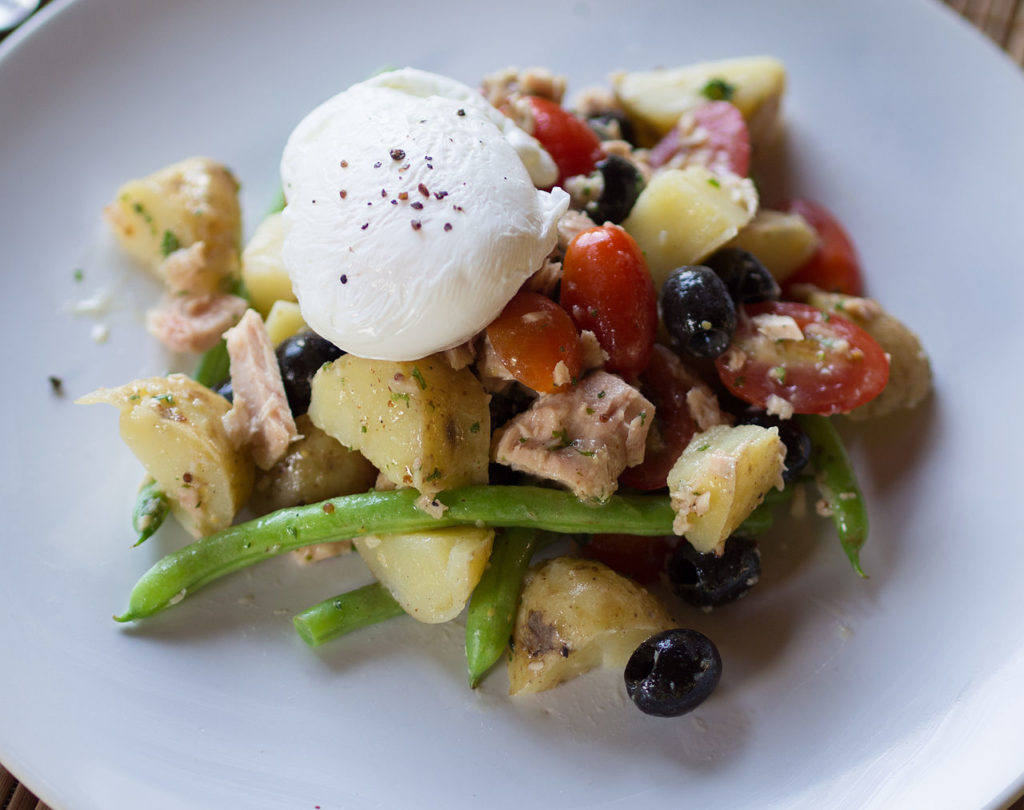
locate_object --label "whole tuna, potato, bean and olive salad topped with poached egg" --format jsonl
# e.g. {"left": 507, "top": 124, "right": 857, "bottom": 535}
{"left": 79, "top": 57, "right": 931, "bottom": 716}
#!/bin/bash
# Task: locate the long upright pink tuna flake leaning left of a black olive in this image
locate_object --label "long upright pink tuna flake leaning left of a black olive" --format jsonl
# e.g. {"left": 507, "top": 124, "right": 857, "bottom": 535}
{"left": 223, "top": 309, "right": 299, "bottom": 470}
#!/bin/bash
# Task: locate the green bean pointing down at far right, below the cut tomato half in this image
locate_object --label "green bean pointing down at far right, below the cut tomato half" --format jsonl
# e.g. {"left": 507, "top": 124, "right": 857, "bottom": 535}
{"left": 798, "top": 415, "right": 867, "bottom": 578}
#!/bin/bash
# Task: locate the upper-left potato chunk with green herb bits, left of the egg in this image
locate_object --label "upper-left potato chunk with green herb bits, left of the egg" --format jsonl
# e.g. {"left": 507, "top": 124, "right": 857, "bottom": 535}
{"left": 103, "top": 158, "right": 242, "bottom": 293}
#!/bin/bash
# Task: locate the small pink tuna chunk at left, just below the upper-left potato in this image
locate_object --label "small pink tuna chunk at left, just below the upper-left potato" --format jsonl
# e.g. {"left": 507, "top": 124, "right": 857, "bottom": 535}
{"left": 145, "top": 293, "right": 249, "bottom": 352}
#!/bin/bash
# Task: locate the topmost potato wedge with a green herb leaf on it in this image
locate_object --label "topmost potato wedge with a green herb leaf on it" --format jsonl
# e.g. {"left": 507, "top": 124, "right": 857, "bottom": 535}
{"left": 612, "top": 56, "right": 785, "bottom": 145}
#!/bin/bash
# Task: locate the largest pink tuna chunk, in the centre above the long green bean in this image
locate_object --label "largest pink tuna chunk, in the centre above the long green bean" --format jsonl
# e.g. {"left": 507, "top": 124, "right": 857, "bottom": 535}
{"left": 492, "top": 371, "right": 654, "bottom": 501}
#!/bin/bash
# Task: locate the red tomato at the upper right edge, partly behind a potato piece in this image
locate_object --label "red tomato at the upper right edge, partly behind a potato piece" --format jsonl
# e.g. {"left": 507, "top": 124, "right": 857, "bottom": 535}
{"left": 780, "top": 200, "right": 864, "bottom": 297}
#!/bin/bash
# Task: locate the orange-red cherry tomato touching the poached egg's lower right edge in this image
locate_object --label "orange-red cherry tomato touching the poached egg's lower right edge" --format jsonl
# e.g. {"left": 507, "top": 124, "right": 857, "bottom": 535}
{"left": 487, "top": 290, "right": 583, "bottom": 393}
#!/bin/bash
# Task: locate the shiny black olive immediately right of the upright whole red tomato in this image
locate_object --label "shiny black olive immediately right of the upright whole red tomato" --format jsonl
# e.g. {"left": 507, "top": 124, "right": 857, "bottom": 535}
{"left": 659, "top": 266, "right": 736, "bottom": 357}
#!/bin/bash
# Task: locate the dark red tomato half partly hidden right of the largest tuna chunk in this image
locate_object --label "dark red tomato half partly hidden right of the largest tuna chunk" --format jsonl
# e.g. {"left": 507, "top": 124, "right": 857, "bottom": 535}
{"left": 618, "top": 345, "right": 697, "bottom": 489}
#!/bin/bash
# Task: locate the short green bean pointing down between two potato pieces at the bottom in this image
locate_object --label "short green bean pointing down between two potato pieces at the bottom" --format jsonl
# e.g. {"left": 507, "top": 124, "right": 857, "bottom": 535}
{"left": 466, "top": 528, "right": 538, "bottom": 688}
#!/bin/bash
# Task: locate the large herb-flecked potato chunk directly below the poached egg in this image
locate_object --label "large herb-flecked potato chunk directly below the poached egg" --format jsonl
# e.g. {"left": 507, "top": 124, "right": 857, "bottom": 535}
{"left": 309, "top": 354, "right": 490, "bottom": 496}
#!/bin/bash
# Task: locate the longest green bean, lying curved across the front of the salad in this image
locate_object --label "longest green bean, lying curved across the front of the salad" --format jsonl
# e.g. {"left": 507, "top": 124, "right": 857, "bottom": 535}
{"left": 115, "top": 485, "right": 675, "bottom": 622}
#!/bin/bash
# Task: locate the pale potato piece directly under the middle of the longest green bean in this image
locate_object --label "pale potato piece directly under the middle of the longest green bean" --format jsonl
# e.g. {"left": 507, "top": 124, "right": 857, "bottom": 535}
{"left": 352, "top": 526, "right": 495, "bottom": 624}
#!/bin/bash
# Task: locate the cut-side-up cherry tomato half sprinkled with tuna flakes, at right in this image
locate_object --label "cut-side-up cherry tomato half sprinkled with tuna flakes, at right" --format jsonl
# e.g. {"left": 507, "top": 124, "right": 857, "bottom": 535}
{"left": 715, "top": 301, "right": 889, "bottom": 415}
